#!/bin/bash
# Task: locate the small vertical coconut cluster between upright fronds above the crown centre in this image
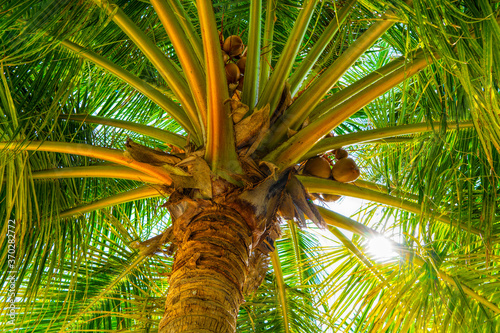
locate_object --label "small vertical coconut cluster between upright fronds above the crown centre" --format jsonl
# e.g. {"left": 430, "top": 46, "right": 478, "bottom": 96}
{"left": 220, "top": 33, "right": 247, "bottom": 91}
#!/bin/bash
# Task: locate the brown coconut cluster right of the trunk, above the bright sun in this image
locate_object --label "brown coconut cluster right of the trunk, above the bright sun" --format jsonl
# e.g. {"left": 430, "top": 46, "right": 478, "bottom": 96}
{"left": 302, "top": 149, "right": 360, "bottom": 202}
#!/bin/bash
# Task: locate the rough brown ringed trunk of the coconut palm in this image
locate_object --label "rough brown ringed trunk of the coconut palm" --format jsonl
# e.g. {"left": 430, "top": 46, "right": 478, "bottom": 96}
{"left": 159, "top": 201, "right": 252, "bottom": 333}
